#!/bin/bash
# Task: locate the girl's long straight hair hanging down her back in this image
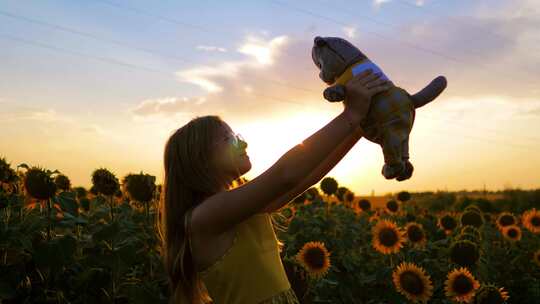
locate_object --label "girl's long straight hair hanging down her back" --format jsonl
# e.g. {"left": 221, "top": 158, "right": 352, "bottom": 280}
{"left": 157, "top": 115, "right": 288, "bottom": 304}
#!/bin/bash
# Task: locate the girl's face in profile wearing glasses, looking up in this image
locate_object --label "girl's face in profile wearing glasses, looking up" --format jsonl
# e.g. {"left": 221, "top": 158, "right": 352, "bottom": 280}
{"left": 212, "top": 124, "right": 251, "bottom": 180}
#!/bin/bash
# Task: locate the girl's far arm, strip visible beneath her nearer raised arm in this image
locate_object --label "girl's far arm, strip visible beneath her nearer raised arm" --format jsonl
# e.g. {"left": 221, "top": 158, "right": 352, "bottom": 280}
{"left": 261, "top": 124, "right": 363, "bottom": 212}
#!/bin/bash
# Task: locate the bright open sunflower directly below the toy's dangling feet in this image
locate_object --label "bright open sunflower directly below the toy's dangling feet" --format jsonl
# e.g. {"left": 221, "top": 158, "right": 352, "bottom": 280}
{"left": 373, "top": 220, "right": 405, "bottom": 254}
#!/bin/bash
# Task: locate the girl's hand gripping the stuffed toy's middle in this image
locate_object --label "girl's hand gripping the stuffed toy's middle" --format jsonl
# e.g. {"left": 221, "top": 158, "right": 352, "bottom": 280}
{"left": 343, "top": 69, "right": 393, "bottom": 121}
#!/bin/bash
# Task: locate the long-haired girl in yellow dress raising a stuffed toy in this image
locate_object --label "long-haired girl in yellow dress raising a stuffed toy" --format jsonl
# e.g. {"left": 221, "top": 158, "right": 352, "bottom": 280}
{"left": 158, "top": 70, "right": 391, "bottom": 304}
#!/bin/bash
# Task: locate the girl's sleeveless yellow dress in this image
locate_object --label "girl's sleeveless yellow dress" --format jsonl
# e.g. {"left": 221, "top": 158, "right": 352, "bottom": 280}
{"left": 187, "top": 209, "right": 299, "bottom": 304}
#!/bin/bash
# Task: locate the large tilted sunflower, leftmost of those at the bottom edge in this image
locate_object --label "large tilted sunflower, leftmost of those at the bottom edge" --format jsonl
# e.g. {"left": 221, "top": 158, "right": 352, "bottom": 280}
{"left": 392, "top": 262, "right": 433, "bottom": 303}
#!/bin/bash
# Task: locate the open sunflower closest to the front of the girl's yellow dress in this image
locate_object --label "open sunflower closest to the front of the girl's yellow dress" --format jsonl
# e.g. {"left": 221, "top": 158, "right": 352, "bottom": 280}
{"left": 296, "top": 242, "right": 330, "bottom": 278}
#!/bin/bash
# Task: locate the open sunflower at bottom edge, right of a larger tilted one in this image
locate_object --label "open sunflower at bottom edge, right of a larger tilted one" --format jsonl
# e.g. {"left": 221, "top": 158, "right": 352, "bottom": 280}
{"left": 444, "top": 267, "right": 480, "bottom": 303}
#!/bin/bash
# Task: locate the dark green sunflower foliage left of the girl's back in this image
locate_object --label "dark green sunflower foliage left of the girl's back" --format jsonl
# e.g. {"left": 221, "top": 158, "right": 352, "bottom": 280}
{"left": 0, "top": 166, "right": 169, "bottom": 304}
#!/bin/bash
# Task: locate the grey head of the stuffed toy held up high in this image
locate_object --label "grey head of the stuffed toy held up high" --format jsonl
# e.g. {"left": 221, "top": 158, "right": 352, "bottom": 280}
{"left": 311, "top": 36, "right": 367, "bottom": 84}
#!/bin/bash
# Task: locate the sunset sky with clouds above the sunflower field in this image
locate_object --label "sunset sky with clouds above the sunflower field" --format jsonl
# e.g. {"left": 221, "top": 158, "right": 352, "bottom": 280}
{"left": 0, "top": 0, "right": 540, "bottom": 194}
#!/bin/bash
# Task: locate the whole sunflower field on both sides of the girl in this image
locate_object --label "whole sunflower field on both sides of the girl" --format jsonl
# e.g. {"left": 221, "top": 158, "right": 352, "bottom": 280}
{"left": 0, "top": 159, "right": 540, "bottom": 304}
